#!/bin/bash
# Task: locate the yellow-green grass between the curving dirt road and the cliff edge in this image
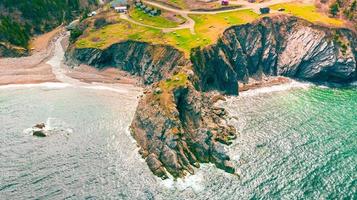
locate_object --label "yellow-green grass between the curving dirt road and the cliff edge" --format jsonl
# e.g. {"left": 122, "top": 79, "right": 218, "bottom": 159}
{"left": 76, "top": 10, "right": 259, "bottom": 57}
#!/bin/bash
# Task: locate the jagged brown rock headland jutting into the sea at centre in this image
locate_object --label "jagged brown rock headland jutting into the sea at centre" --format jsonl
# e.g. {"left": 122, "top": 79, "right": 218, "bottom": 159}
{"left": 131, "top": 72, "right": 236, "bottom": 179}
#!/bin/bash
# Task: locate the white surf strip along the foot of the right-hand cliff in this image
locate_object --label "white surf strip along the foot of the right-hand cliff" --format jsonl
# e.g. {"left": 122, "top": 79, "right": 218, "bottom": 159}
{"left": 239, "top": 81, "right": 313, "bottom": 97}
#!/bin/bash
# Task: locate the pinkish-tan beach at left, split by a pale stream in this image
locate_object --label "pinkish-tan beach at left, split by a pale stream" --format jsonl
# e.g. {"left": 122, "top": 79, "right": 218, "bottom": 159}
{"left": 0, "top": 27, "right": 138, "bottom": 85}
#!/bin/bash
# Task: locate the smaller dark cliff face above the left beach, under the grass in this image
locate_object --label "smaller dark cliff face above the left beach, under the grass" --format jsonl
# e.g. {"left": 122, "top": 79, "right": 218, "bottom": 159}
{"left": 66, "top": 41, "right": 189, "bottom": 85}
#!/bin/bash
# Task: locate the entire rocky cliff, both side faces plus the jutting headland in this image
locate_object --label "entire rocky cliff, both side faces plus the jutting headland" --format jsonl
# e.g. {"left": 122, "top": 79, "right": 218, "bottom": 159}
{"left": 67, "top": 16, "right": 357, "bottom": 178}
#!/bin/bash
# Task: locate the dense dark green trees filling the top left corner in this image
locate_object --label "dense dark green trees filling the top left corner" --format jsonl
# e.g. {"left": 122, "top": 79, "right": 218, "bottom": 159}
{"left": 0, "top": 0, "right": 97, "bottom": 48}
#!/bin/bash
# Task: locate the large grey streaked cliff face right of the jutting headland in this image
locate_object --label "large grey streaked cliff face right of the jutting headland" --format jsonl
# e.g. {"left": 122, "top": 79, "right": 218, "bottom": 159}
{"left": 191, "top": 16, "right": 357, "bottom": 94}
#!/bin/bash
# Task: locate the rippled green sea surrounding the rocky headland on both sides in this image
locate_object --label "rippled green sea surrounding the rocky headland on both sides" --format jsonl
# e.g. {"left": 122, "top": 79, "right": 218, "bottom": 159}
{"left": 0, "top": 87, "right": 357, "bottom": 199}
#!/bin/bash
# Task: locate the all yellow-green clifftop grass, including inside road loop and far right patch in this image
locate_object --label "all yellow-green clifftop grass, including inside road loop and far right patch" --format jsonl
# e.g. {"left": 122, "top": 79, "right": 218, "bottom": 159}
{"left": 75, "top": 3, "right": 344, "bottom": 58}
